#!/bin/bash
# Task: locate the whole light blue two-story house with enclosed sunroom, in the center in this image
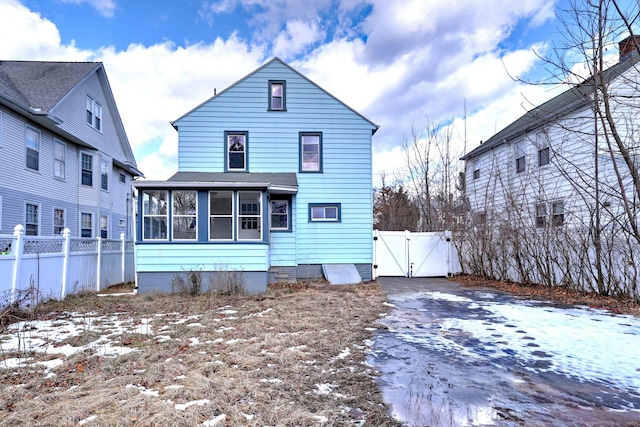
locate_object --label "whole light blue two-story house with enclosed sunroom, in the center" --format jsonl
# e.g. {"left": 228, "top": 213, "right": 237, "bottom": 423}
{"left": 135, "top": 58, "right": 378, "bottom": 292}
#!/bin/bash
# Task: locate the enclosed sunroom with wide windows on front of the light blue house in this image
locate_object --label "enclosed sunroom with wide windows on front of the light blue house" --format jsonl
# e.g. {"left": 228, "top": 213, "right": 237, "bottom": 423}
{"left": 135, "top": 172, "right": 298, "bottom": 292}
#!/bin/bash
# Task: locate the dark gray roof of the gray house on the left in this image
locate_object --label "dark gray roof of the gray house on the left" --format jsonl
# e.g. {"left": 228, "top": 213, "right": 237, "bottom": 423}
{"left": 0, "top": 61, "right": 142, "bottom": 176}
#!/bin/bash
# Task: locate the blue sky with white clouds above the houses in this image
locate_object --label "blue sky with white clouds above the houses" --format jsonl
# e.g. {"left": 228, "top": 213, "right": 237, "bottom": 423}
{"left": 0, "top": 0, "right": 616, "bottom": 185}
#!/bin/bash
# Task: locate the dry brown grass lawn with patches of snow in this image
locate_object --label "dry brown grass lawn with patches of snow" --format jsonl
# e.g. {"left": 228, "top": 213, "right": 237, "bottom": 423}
{"left": 0, "top": 283, "right": 399, "bottom": 426}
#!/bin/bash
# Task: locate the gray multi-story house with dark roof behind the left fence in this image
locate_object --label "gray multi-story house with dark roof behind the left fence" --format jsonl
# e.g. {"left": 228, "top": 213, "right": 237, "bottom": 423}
{"left": 0, "top": 61, "right": 142, "bottom": 238}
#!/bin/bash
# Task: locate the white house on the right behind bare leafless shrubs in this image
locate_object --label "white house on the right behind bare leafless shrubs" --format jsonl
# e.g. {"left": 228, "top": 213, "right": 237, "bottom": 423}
{"left": 462, "top": 37, "right": 640, "bottom": 293}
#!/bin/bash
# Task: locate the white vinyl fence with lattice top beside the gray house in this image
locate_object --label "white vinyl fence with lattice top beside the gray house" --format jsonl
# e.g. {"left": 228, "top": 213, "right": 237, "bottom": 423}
{"left": 0, "top": 224, "right": 135, "bottom": 305}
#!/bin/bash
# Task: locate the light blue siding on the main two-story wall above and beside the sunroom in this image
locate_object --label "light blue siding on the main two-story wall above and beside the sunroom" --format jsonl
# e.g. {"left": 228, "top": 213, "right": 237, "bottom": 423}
{"left": 173, "top": 60, "right": 375, "bottom": 266}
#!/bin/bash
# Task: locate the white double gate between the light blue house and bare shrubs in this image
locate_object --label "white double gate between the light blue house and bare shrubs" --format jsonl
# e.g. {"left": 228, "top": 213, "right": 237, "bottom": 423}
{"left": 373, "top": 230, "right": 460, "bottom": 279}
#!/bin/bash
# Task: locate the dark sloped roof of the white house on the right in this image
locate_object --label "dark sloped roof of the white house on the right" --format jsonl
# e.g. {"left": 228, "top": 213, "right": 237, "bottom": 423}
{"left": 461, "top": 55, "right": 638, "bottom": 160}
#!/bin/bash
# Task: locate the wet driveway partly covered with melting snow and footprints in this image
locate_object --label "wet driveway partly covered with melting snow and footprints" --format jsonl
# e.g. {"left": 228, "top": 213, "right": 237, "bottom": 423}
{"left": 370, "top": 277, "right": 640, "bottom": 427}
